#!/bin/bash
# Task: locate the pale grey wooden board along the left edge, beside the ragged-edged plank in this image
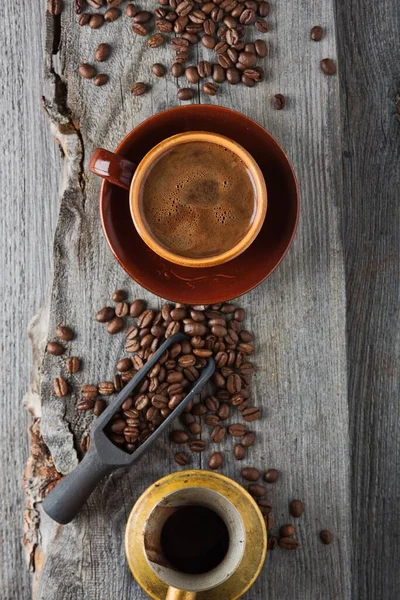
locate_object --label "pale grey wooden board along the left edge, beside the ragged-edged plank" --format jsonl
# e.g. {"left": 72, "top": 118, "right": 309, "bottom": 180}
{"left": 0, "top": 1, "right": 60, "bottom": 600}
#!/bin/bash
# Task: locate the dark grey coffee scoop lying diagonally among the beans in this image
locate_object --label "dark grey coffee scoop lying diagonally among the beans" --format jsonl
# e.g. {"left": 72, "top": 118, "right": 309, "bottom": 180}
{"left": 43, "top": 333, "right": 215, "bottom": 525}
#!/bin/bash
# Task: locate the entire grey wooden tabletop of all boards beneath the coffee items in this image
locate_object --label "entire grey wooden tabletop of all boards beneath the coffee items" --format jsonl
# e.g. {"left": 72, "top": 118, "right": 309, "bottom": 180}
{"left": 0, "top": 0, "right": 400, "bottom": 600}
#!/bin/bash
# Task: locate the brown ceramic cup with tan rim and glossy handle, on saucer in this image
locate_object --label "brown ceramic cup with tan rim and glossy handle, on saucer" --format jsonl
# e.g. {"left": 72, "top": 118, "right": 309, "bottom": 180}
{"left": 89, "top": 131, "right": 267, "bottom": 268}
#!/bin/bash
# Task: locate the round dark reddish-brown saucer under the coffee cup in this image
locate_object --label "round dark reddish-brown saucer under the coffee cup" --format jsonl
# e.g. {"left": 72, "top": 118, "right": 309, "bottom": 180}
{"left": 100, "top": 104, "right": 299, "bottom": 304}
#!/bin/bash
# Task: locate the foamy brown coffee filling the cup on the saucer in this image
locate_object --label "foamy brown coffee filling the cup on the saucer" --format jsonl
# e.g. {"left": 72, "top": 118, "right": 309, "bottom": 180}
{"left": 140, "top": 142, "right": 256, "bottom": 258}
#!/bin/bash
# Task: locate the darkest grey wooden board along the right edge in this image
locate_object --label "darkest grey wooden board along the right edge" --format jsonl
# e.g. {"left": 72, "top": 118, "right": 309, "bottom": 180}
{"left": 337, "top": 0, "right": 400, "bottom": 598}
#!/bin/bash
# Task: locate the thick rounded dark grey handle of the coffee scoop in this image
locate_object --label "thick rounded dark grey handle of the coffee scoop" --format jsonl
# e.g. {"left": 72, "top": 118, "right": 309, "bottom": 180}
{"left": 43, "top": 445, "right": 115, "bottom": 525}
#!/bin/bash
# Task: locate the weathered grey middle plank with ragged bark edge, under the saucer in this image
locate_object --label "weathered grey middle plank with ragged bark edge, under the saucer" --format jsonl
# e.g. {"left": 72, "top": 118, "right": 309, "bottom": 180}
{"left": 38, "top": 0, "right": 350, "bottom": 600}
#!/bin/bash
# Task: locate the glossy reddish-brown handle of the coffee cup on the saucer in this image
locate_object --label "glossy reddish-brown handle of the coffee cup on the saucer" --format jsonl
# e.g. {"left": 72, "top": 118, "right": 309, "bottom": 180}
{"left": 89, "top": 148, "right": 136, "bottom": 190}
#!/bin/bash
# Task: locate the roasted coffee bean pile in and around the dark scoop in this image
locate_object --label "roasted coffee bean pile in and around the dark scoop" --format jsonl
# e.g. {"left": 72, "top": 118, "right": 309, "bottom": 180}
{"left": 92, "top": 290, "right": 261, "bottom": 452}
